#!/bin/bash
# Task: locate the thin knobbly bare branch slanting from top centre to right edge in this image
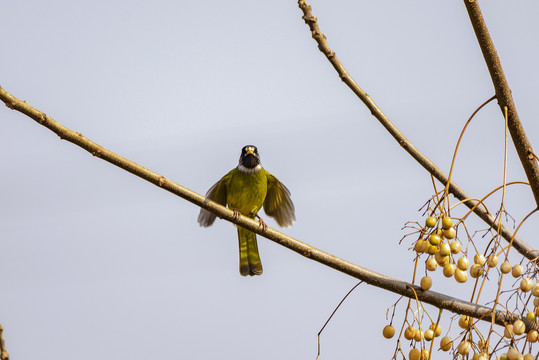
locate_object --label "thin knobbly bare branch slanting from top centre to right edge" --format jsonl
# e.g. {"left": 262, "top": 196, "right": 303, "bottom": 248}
{"left": 298, "top": 0, "right": 539, "bottom": 262}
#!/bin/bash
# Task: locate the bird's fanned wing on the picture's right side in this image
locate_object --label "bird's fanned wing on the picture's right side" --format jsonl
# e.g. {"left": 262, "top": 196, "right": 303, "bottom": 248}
{"left": 264, "top": 173, "right": 296, "bottom": 227}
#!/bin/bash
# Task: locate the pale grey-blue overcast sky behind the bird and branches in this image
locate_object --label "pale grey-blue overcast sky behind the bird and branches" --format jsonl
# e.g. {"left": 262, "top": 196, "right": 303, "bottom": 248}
{"left": 0, "top": 0, "right": 539, "bottom": 360}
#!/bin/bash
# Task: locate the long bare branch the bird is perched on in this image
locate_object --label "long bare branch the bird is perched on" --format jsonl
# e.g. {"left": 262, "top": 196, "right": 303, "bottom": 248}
{"left": 0, "top": 87, "right": 529, "bottom": 325}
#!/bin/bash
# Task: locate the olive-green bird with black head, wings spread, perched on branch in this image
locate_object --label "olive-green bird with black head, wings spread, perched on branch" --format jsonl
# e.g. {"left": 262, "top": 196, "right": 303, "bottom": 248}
{"left": 198, "top": 145, "right": 296, "bottom": 276}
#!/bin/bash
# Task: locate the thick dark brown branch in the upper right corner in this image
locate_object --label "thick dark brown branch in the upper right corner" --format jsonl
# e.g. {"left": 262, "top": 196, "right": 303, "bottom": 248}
{"left": 464, "top": 0, "right": 539, "bottom": 206}
